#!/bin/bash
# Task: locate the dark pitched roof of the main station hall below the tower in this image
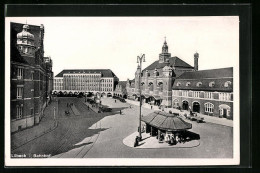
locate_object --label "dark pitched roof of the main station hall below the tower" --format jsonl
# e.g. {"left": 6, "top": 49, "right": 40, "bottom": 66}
{"left": 143, "top": 56, "right": 193, "bottom": 71}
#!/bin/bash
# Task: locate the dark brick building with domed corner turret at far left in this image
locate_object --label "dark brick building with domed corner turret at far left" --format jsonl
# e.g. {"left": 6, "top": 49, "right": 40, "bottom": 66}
{"left": 10, "top": 23, "right": 53, "bottom": 132}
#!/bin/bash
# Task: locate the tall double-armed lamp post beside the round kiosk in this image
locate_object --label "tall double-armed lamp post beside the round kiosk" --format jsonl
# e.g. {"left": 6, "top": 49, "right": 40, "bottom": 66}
{"left": 137, "top": 54, "right": 145, "bottom": 141}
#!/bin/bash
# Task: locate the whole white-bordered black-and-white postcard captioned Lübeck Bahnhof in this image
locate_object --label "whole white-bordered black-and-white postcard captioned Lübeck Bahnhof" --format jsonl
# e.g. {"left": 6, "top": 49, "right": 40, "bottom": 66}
{"left": 5, "top": 16, "right": 240, "bottom": 166}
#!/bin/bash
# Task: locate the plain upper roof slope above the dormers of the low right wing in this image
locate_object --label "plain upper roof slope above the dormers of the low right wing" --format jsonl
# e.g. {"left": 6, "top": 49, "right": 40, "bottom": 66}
{"left": 177, "top": 67, "right": 233, "bottom": 79}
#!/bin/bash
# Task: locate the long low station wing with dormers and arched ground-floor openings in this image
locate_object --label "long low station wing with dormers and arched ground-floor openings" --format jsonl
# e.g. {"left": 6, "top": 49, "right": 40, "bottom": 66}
{"left": 172, "top": 67, "right": 233, "bottom": 119}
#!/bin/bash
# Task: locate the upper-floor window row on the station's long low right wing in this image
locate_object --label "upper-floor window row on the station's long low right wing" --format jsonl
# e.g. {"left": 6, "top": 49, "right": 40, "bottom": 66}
{"left": 172, "top": 90, "right": 232, "bottom": 101}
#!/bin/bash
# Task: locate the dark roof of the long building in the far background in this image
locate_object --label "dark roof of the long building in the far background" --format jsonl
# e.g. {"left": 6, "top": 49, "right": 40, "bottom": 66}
{"left": 55, "top": 69, "right": 116, "bottom": 77}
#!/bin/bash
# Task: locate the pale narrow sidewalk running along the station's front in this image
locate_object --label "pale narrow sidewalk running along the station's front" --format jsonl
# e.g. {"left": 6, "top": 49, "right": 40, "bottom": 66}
{"left": 126, "top": 99, "right": 233, "bottom": 127}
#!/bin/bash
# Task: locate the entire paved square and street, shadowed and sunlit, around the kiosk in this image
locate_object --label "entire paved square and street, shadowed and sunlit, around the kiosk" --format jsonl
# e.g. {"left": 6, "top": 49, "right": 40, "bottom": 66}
{"left": 12, "top": 98, "right": 233, "bottom": 158}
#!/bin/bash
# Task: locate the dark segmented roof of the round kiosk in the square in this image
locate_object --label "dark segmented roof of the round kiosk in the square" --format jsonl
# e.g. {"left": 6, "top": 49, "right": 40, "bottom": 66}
{"left": 142, "top": 111, "right": 192, "bottom": 131}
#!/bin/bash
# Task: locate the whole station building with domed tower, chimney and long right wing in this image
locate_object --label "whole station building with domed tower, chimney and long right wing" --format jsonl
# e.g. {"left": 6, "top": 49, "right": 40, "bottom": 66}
{"left": 126, "top": 38, "right": 233, "bottom": 119}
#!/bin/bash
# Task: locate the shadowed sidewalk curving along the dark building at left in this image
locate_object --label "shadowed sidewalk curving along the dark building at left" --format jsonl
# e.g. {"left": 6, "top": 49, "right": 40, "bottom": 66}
{"left": 11, "top": 101, "right": 58, "bottom": 150}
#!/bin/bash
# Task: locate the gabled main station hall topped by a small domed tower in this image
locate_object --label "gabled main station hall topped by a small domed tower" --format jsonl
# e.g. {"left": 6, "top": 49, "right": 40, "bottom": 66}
{"left": 127, "top": 40, "right": 198, "bottom": 107}
